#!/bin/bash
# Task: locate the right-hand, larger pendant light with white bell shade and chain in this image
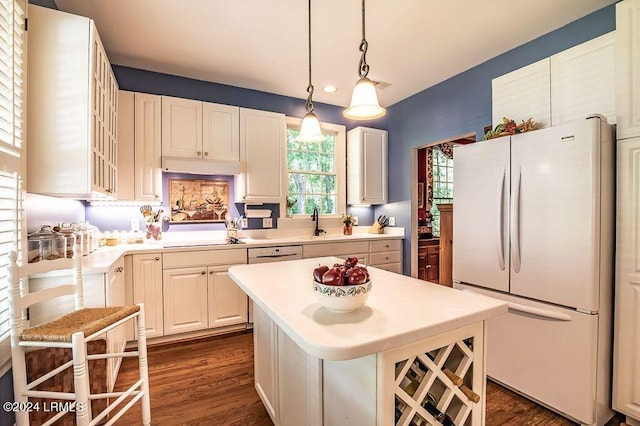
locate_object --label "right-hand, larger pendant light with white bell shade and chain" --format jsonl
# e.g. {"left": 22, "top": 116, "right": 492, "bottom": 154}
{"left": 342, "top": 0, "right": 387, "bottom": 120}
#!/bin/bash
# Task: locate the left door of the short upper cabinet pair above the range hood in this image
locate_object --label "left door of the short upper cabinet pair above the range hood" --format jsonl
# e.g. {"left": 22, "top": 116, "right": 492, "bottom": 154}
{"left": 162, "top": 96, "right": 202, "bottom": 158}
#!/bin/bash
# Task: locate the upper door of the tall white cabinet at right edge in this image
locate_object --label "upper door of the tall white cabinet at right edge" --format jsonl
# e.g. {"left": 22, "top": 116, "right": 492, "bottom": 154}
{"left": 616, "top": 0, "right": 640, "bottom": 139}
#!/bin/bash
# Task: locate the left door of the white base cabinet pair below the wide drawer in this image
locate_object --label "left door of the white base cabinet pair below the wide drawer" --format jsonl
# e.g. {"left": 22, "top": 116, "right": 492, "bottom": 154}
{"left": 162, "top": 266, "right": 208, "bottom": 335}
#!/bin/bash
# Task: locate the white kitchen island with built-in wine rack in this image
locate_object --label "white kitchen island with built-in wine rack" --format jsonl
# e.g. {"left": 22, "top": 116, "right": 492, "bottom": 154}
{"left": 229, "top": 257, "right": 507, "bottom": 426}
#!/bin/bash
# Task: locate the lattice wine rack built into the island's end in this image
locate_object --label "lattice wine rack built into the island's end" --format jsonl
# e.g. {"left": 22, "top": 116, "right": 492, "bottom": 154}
{"left": 383, "top": 325, "right": 485, "bottom": 426}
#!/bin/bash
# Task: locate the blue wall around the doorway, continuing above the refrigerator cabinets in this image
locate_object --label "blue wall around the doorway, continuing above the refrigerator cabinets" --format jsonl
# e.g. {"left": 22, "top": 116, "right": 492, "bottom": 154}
{"left": 374, "top": 5, "right": 615, "bottom": 274}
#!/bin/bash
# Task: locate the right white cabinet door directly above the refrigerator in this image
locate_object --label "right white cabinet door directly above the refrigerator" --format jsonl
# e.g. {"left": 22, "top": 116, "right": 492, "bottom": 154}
{"left": 551, "top": 31, "right": 616, "bottom": 126}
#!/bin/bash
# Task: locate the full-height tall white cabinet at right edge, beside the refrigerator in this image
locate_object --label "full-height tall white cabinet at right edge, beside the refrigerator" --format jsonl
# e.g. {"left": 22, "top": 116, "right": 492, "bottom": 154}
{"left": 613, "top": 0, "right": 640, "bottom": 426}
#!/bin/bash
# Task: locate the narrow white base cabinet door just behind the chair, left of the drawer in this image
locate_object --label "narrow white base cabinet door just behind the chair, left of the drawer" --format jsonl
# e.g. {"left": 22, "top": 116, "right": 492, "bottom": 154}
{"left": 131, "top": 253, "right": 164, "bottom": 340}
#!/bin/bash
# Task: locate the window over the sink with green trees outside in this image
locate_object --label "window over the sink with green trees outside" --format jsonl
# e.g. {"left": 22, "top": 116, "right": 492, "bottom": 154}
{"left": 287, "top": 118, "right": 346, "bottom": 217}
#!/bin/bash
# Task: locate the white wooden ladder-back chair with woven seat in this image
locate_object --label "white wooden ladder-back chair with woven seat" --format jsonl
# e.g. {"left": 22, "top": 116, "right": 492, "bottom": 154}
{"left": 8, "top": 252, "right": 151, "bottom": 426}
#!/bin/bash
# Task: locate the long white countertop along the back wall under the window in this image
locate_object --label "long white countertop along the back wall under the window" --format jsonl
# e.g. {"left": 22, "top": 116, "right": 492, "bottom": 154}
{"left": 77, "top": 228, "right": 404, "bottom": 274}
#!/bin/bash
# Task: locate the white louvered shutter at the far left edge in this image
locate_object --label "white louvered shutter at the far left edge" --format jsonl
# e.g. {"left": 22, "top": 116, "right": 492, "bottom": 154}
{"left": 0, "top": 0, "right": 26, "bottom": 366}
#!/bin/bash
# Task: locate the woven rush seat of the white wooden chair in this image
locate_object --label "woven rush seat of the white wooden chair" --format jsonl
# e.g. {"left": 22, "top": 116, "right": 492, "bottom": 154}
{"left": 20, "top": 305, "right": 140, "bottom": 342}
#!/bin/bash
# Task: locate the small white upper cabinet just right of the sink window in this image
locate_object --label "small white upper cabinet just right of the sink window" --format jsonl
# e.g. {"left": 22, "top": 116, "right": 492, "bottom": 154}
{"left": 347, "top": 127, "right": 388, "bottom": 205}
